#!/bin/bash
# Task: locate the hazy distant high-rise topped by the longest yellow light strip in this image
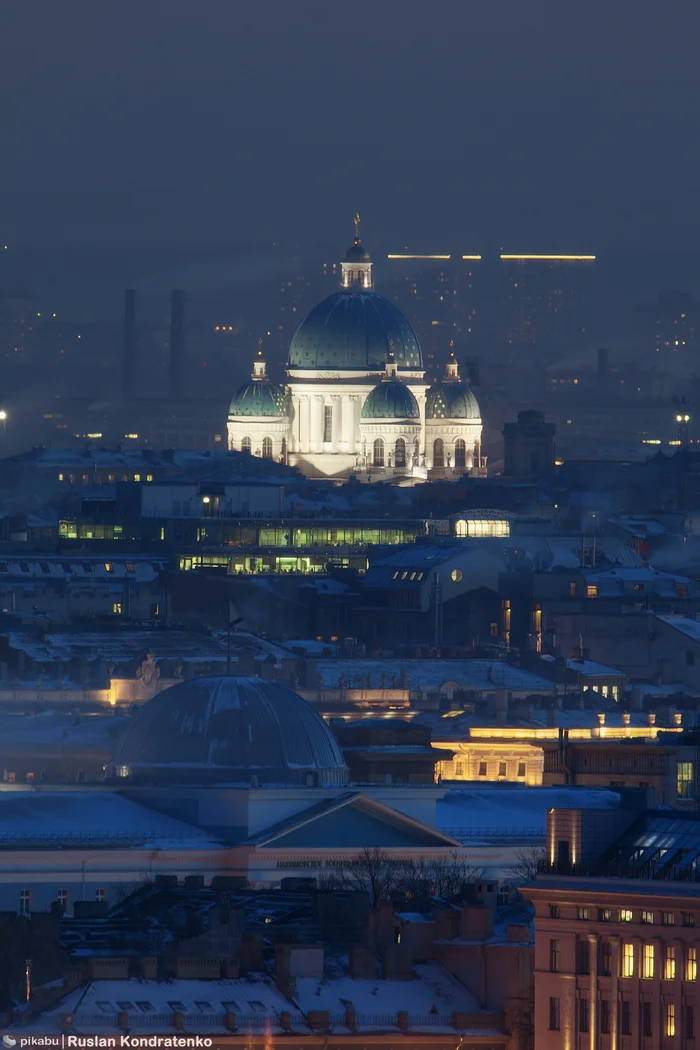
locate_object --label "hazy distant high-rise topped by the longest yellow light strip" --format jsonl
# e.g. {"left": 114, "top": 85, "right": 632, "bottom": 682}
{"left": 501, "top": 254, "right": 595, "bottom": 349}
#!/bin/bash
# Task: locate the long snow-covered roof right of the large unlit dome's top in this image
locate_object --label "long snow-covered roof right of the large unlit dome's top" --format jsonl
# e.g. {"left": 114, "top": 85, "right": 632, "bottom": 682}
{"left": 310, "top": 659, "right": 554, "bottom": 693}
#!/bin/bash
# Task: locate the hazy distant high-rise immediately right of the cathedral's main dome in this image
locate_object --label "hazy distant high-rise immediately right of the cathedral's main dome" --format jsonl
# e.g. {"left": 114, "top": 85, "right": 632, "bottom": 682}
{"left": 385, "top": 252, "right": 481, "bottom": 370}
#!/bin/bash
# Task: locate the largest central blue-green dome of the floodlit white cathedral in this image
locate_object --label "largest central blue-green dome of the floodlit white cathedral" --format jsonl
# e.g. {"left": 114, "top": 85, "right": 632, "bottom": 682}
{"left": 290, "top": 291, "right": 423, "bottom": 372}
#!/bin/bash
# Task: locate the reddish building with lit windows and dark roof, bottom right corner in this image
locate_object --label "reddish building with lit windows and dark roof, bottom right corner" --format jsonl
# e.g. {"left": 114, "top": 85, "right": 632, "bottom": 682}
{"left": 528, "top": 809, "right": 700, "bottom": 1050}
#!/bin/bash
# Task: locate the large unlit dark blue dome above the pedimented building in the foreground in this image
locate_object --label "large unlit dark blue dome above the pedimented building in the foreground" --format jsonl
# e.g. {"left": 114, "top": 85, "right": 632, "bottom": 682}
{"left": 108, "top": 675, "right": 347, "bottom": 788}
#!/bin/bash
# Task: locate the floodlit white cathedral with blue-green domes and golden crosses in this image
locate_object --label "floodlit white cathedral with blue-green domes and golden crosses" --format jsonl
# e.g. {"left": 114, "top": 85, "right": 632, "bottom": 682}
{"left": 228, "top": 223, "right": 486, "bottom": 484}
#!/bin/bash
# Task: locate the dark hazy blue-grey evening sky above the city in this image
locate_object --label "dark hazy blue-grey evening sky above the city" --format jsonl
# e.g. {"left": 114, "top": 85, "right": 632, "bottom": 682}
{"left": 0, "top": 0, "right": 700, "bottom": 254}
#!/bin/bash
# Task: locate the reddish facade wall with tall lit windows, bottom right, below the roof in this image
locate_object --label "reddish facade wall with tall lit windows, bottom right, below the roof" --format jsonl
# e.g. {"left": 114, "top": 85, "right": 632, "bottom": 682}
{"left": 531, "top": 879, "right": 700, "bottom": 1050}
